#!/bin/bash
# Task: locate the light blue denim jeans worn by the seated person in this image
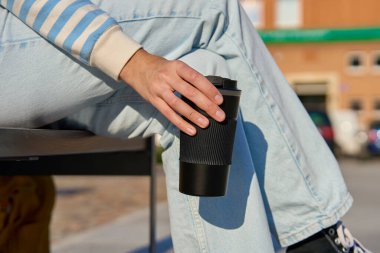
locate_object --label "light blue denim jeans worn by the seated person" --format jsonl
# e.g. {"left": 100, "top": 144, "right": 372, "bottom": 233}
{"left": 0, "top": 0, "right": 352, "bottom": 253}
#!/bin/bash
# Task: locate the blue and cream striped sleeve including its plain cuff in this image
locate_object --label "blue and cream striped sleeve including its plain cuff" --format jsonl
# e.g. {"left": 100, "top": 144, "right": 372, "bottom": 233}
{"left": 0, "top": 0, "right": 141, "bottom": 80}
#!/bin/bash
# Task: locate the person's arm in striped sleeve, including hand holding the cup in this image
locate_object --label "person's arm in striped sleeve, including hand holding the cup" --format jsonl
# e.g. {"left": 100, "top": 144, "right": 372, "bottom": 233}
{"left": 0, "top": 0, "right": 225, "bottom": 135}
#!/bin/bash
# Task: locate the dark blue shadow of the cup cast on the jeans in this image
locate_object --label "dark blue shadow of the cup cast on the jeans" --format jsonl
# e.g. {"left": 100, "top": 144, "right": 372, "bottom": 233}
{"left": 199, "top": 120, "right": 268, "bottom": 229}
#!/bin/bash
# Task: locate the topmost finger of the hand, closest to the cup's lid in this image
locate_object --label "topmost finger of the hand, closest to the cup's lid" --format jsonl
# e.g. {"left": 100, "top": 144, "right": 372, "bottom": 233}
{"left": 177, "top": 62, "right": 223, "bottom": 105}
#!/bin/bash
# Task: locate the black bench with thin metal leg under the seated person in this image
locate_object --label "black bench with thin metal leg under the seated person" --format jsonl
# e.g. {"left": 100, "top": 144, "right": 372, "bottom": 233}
{"left": 0, "top": 128, "right": 156, "bottom": 253}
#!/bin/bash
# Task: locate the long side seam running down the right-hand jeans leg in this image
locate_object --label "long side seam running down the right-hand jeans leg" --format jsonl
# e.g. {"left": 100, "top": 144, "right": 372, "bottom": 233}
{"left": 225, "top": 31, "right": 325, "bottom": 214}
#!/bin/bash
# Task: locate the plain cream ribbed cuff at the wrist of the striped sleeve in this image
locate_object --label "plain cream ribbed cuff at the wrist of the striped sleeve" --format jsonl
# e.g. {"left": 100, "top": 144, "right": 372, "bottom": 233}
{"left": 90, "top": 26, "right": 142, "bottom": 80}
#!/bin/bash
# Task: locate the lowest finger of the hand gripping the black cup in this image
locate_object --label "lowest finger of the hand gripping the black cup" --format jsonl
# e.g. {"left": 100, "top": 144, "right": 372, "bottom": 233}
{"left": 154, "top": 99, "right": 196, "bottom": 136}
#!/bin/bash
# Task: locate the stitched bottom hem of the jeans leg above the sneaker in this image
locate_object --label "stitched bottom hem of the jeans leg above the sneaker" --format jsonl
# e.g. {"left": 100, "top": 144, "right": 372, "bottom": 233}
{"left": 279, "top": 193, "right": 352, "bottom": 247}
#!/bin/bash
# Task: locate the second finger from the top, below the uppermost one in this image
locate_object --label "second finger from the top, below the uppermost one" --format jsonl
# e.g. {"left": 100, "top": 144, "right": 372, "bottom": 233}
{"left": 170, "top": 79, "right": 226, "bottom": 121}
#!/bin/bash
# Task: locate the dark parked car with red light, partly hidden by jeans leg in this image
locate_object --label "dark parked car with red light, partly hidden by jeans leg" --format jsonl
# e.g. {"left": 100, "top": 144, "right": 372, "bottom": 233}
{"left": 308, "top": 111, "right": 335, "bottom": 153}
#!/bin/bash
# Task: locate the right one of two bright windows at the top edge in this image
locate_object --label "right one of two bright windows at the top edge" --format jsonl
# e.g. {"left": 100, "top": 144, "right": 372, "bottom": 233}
{"left": 275, "top": 0, "right": 302, "bottom": 28}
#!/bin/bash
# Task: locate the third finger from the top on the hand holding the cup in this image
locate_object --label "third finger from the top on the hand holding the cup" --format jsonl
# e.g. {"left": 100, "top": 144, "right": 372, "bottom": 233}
{"left": 163, "top": 90, "right": 209, "bottom": 128}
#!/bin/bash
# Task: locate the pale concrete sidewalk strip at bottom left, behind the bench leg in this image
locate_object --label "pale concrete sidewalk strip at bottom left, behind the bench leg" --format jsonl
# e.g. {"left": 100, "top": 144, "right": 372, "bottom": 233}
{"left": 52, "top": 202, "right": 173, "bottom": 253}
